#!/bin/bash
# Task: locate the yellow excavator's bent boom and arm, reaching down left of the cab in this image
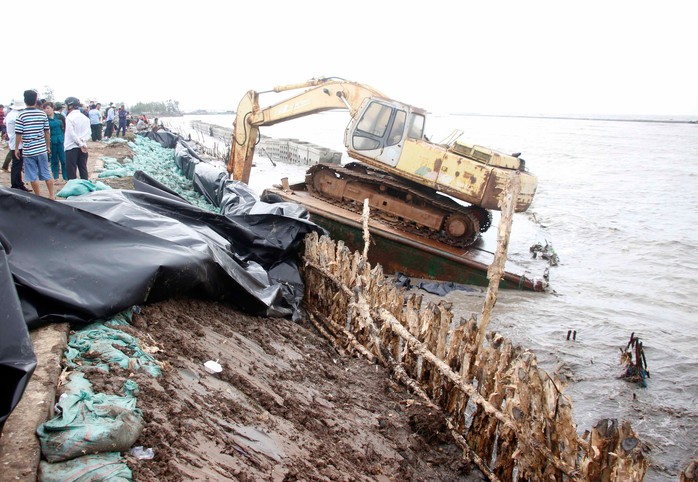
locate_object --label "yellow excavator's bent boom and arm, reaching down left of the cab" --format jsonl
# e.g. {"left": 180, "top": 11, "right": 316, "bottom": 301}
{"left": 228, "top": 78, "right": 387, "bottom": 183}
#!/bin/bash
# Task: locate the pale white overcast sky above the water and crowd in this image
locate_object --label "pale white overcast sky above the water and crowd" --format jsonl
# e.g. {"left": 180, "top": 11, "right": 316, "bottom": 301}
{"left": 5, "top": 0, "right": 698, "bottom": 116}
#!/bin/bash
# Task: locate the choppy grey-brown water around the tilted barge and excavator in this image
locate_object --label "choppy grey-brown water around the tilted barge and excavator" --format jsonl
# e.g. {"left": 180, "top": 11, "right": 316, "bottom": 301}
{"left": 165, "top": 112, "right": 698, "bottom": 481}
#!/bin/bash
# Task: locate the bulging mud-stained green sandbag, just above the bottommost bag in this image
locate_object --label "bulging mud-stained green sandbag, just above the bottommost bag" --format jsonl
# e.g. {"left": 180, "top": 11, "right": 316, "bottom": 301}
{"left": 36, "top": 372, "right": 143, "bottom": 462}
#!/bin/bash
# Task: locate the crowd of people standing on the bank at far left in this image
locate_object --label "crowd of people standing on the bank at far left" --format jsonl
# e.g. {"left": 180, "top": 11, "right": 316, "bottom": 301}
{"left": 0, "top": 89, "right": 147, "bottom": 199}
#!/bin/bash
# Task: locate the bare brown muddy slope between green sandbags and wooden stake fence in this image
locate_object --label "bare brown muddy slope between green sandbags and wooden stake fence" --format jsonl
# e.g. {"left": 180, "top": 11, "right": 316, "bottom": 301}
{"left": 0, "top": 137, "right": 484, "bottom": 481}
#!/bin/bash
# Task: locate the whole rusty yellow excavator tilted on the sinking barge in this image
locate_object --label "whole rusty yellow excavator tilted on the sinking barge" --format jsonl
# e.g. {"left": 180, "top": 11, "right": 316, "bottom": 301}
{"left": 227, "top": 77, "right": 537, "bottom": 247}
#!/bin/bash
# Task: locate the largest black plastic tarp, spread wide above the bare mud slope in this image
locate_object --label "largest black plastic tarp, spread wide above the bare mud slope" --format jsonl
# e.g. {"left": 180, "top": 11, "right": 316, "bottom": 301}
{"left": 0, "top": 184, "right": 317, "bottom": 327}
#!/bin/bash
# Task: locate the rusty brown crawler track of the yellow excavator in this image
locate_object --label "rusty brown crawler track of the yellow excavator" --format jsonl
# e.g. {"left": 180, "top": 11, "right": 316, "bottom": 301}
{"left": 305, "top": 162, "right": 492, "bottom": 248}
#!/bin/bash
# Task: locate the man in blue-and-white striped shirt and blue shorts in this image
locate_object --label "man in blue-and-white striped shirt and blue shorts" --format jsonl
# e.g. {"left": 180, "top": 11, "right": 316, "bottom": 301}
{"left": 12, "top": 90, "right": 56, "bottom": 200}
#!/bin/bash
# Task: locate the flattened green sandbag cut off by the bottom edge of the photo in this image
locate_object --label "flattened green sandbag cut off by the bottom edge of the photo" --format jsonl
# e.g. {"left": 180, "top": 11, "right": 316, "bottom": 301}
{"left": 38, "top": 452, "right": 133, "bottom": 482}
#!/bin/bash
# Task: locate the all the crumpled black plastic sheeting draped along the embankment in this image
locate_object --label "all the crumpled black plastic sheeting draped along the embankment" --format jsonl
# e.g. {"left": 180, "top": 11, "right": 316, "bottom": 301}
{"left": 0, "top": 132, "right": 324, "bottom": 434}
